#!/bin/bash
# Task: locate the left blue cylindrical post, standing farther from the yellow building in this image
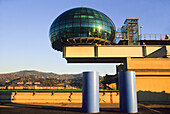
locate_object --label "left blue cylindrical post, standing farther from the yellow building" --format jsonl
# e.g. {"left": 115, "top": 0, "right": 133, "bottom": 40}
{"left": 82, "top": 72, "right": 99, "bottom": 113}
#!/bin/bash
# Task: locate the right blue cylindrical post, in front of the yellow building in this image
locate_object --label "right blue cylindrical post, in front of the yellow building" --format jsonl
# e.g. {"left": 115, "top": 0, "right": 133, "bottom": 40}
{"left": 119, "top": 71, "right": 138, "bottom": 113}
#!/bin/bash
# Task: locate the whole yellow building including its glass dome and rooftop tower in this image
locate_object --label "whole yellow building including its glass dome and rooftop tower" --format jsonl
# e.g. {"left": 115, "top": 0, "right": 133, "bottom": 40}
{"left": 50, "top": 7, "right": 170, "bottom": 103}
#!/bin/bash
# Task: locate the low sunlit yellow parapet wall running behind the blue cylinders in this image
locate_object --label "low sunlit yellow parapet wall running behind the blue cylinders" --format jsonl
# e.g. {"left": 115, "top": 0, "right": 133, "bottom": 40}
{"left": 0, "top": 91, "right": 119, "bottom": 103}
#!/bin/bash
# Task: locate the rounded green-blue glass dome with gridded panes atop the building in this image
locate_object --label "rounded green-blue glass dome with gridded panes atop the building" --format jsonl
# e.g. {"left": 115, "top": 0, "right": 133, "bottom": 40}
{"left": 49, "top": 7, "right": 116, "bottom": 51}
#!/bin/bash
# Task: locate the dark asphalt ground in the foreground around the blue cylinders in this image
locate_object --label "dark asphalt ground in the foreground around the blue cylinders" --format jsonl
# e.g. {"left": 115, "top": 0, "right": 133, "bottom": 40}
{"left": 0, "top": 103, "right": 170, "bottom": 114}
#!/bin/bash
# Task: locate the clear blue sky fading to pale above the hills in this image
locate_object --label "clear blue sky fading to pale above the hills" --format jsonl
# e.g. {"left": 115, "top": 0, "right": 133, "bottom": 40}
{"left": 0, "top": 0, "right": 170, "bottom": 75}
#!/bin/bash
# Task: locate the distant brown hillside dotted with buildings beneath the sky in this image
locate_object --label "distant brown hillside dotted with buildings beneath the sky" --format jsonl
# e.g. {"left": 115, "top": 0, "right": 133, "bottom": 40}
{"left": 0, "top": 70, "right": 102, "bottom": 86}
